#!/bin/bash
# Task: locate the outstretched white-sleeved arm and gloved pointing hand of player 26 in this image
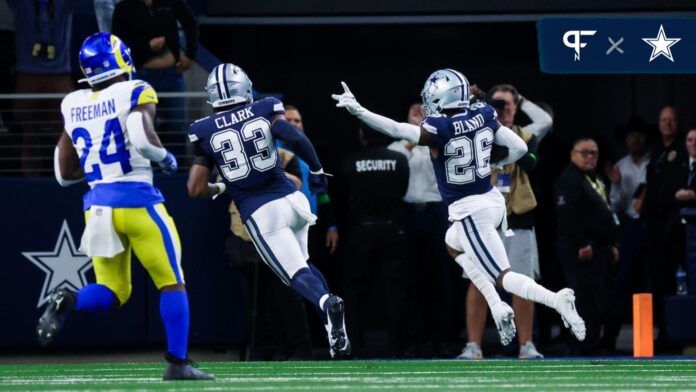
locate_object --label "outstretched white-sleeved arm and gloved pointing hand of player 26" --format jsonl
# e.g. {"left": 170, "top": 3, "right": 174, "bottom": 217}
{"left": 331, "top": 82, "right": 436, "bottom": 147}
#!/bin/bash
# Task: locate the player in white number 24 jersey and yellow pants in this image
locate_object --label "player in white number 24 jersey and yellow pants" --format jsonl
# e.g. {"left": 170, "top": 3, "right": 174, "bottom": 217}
{"left": 37, "top": 33, "right": 213, "bottom": 380}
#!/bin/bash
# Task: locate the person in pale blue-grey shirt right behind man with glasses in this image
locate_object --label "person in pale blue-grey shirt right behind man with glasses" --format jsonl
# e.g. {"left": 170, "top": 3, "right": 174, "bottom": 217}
{"left": 602, "top": 122, "right": 650, "bottom": 351}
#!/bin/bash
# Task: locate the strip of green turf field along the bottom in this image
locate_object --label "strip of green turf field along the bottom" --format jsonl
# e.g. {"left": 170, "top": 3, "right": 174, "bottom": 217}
{"left": 0, "top": 360, "right": 696, "bottom": 391}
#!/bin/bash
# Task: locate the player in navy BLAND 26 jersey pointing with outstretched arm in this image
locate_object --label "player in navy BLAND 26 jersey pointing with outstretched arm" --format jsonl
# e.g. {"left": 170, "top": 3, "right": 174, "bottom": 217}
{"left": 332, "top": 69, "right": 585, "bottom": 345}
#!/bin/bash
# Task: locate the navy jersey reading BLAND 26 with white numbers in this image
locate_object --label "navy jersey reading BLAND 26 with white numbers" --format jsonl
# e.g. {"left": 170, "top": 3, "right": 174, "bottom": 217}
{"left": 421, "top": 103, "right": 498, "bottom": 204}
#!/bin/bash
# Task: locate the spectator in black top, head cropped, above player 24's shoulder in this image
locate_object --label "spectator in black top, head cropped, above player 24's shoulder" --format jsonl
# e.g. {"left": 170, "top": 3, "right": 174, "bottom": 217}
{"left": 111, "top": 0, "right": 198, "bottom": 139}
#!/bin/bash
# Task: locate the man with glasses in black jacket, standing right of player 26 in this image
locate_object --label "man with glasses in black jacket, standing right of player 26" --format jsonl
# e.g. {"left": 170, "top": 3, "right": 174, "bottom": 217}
{"left": 555, "top": 139, "right": 619, "bottom": 355}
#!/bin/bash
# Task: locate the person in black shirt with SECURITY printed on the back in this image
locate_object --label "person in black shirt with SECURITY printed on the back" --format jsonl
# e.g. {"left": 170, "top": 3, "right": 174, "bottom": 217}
{"left": 341, "top": 127, "right": 410, "bottom": 357}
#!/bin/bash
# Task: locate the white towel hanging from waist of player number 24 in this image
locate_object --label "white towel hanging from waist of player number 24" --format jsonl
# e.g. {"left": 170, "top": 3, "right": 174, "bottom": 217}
{"left": 80, "top": 206, "right": 125, "bottom": 257}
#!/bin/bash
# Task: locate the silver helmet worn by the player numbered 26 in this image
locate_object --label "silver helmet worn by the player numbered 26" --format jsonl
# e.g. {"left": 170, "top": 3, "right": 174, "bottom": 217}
{"left": 421, "top": 68, "right": 469, "bottom": 116}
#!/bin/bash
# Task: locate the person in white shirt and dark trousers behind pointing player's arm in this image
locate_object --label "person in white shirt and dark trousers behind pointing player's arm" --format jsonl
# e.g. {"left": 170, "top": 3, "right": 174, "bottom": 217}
{"left": 388, "top": 103, "right": 460, "bottom": 358}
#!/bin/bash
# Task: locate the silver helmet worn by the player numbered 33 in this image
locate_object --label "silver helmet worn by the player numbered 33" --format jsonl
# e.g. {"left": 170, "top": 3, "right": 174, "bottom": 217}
{"left": 205, "top": 63, "right": 254, "bottom": 108}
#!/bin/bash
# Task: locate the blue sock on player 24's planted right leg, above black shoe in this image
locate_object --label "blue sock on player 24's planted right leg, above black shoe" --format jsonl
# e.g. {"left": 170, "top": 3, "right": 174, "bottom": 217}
{"left": 160, "top": 291, "right": 189, "bottom": 359}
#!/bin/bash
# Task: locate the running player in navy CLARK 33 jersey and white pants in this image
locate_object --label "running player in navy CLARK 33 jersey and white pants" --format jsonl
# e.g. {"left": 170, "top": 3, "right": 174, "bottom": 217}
{"left": 188, "top": 64, "right": 350, "bottom": 357}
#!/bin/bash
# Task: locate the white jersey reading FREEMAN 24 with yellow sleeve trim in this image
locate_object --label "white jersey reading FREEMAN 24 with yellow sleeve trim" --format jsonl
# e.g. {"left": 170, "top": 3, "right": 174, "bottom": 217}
{"left": 61, "top": 80, "right": 157, "bottom": 187}
